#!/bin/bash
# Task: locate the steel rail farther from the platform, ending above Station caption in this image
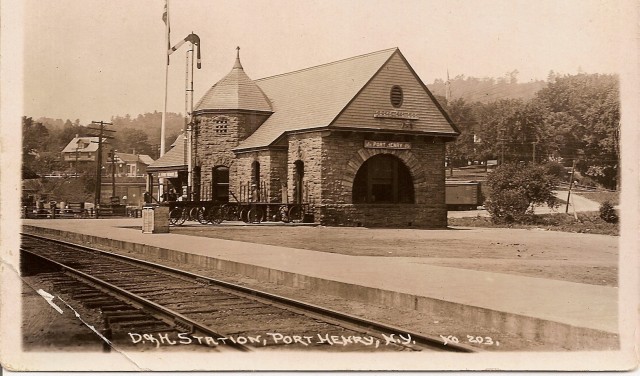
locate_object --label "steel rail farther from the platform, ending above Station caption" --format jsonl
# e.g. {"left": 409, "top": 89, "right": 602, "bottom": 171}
{"left": 20, "top": 247, "right": 251, "bottom": 351}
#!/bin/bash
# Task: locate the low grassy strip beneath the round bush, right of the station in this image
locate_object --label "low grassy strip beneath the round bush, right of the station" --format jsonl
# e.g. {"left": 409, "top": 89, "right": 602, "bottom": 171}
{"left": 449, "top": 212, "right": 620, "bottom": 236}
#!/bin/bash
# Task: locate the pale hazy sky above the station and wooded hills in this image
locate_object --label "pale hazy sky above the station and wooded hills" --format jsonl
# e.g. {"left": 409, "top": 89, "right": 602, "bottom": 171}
{"left": 17, "top": 0, "right": 628, "bottom": 124}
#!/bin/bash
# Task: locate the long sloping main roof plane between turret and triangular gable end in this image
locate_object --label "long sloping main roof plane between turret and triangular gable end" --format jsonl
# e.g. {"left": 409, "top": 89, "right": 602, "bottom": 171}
{"left": 236, "top": 48, "right": 398, "bottom": 150}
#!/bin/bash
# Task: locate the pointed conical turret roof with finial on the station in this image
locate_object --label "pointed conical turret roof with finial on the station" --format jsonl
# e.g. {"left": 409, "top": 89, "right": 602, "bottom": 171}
{"left": 194, "top": 47, "right": 273, "bottom": 112}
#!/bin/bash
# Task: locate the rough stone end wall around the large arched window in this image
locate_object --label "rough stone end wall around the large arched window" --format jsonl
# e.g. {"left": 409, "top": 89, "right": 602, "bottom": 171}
{"left": 314, "top": 132, "right": 447, "bottom": 228}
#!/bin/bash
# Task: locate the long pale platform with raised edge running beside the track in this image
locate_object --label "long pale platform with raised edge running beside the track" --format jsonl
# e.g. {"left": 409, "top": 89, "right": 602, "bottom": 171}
{"left": 22, "top": 218, "right": 618, "bottom": 348}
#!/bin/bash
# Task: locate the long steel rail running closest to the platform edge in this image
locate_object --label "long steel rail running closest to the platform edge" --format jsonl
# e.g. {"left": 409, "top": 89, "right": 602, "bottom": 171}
{"left": 21, "top": 233, "right": 478, "bottom": 353}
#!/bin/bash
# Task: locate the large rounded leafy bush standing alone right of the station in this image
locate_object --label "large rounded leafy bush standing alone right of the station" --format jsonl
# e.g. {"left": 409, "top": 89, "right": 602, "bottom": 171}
{"left": 485, "top": 164, "right": 558, "bottom": 223}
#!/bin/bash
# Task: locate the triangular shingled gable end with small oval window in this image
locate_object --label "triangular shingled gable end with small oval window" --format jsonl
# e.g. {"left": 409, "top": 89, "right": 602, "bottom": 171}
{"left": 331, "top": 51, "right": 459, "bottom": 136}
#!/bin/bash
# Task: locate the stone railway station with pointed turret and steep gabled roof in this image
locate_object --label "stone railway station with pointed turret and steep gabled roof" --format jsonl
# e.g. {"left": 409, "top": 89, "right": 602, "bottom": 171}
{"left": 150, "top": 48, "right": 459, "bottom": 228}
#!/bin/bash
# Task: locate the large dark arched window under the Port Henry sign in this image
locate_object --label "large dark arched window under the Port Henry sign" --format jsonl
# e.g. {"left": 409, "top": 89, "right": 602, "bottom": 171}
{"left": 352, "top": 154, "right": 414, "bottom": 204}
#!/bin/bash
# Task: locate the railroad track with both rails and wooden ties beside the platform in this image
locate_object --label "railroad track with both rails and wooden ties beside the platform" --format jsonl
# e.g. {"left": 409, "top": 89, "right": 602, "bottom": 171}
{"left": 20, "top": 234, "right": 475, "bottom": 352}
